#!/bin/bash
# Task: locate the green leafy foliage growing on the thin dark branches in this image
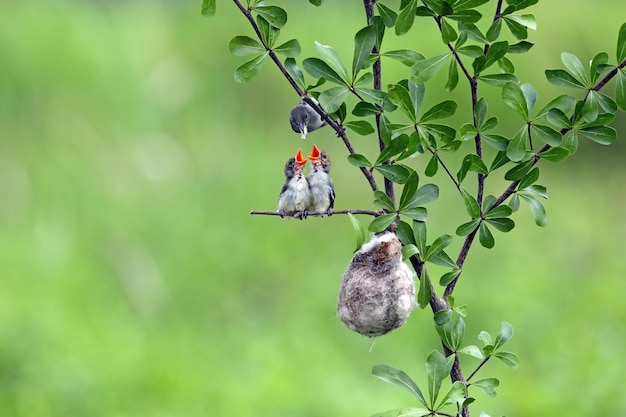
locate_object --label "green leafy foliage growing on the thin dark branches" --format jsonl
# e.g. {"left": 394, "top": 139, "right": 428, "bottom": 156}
{"left": 202, "top": 0, "right": 626, "bottom": 416}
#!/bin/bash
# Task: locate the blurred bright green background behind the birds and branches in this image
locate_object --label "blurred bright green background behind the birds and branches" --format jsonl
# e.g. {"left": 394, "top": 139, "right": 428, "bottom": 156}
{"left": 0, "top": 0, "right": 626, "bottom": 417}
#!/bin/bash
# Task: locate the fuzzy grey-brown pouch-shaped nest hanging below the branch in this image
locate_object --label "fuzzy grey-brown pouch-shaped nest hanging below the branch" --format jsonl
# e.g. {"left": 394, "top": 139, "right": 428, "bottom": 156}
{"left": 337, "top": 232, "right": 416, "bottom": 337}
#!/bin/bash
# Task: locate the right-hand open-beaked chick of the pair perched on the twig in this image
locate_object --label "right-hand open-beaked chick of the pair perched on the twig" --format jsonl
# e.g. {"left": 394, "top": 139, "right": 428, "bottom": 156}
{"left": 306, "top": 145, "right": 335, "bottom": 216}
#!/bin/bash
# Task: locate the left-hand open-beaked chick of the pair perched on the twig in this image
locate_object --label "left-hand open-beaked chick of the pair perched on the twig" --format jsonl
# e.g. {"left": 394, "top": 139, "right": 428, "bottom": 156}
{"left": 278, "top": 149, "right": 311, "bottom": 219}
